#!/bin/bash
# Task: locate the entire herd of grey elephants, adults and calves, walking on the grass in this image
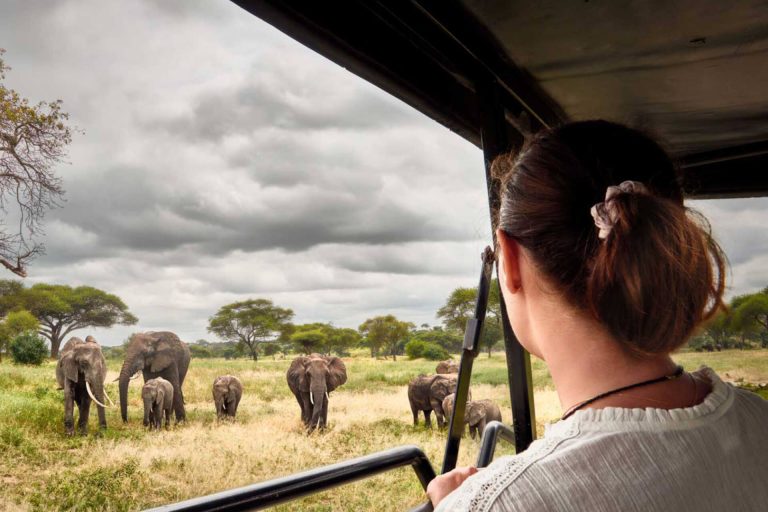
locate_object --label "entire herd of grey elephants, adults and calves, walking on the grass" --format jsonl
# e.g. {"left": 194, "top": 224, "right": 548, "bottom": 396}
{"left": 56, "top": 338, "right": 501, "bottom": 437}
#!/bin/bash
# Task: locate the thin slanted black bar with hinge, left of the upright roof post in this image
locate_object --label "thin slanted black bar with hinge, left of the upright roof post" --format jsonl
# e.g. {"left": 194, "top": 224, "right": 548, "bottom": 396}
{"left": 441, "top": 247, "right": 495, "bottom": 473}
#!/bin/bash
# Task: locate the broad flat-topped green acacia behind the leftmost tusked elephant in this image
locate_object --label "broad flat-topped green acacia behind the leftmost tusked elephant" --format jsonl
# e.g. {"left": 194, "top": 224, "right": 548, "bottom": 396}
{"left": 0, "top": 281, "right": 138, "bottom": 358}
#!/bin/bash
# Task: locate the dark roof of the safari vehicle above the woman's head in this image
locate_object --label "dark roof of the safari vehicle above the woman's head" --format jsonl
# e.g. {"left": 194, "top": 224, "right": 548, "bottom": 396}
{"left": 235, "top": 0, "right": 768, "bottom": 197}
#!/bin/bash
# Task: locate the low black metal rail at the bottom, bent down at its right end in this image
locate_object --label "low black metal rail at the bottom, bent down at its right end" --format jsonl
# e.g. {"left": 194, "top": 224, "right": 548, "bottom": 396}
{"left": 142, "top": 446, "right": 435, "bottom": 512}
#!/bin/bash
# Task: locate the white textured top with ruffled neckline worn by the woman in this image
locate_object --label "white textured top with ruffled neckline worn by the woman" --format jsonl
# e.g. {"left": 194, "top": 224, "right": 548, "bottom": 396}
{"left": 437, "top": 367, "right": 768, "bottom": 512}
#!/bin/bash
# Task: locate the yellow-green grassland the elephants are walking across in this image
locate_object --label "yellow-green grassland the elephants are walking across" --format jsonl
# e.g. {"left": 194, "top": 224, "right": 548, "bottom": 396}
{"left": 0, "top": 350, "right": 768, "bottom": 511}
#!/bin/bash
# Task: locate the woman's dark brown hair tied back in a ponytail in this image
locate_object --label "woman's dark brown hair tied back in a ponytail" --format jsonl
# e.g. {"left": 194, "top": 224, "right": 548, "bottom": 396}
{"left": 493, "top": 121, "right": 725, "bottom": 355}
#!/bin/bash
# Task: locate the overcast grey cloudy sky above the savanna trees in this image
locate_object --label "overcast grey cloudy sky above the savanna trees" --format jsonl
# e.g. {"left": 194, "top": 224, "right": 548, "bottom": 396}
{"left": 0, "top": 0, "right": 768, "bottom": 345}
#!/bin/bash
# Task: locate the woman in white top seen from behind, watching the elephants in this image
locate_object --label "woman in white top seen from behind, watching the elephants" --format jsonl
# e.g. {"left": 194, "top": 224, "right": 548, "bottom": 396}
{"left": 427, "top": 121, "right": 768, "bottom": 512}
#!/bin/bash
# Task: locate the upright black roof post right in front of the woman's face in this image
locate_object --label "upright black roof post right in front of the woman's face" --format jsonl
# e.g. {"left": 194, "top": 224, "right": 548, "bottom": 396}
{"left": 476, "top": 78, "right": 536, "bottom": 453}
